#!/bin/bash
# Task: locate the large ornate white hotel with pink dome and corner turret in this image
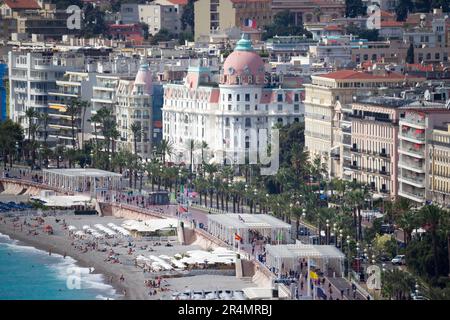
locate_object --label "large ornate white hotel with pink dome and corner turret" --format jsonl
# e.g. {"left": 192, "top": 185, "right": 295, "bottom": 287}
{"left": 163, "top": 39, "right": 303, "bottom": 164}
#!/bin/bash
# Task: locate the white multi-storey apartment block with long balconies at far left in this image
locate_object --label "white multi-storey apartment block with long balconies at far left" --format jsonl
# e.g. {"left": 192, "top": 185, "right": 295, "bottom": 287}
{"left": 8, "top": 49, "right": 85, "bottom": 132}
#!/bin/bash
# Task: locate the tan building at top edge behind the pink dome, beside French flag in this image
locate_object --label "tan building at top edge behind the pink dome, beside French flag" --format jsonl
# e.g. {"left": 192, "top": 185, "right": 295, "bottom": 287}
{"left": 194, "top": 0, "right": 272, "bottom": 40}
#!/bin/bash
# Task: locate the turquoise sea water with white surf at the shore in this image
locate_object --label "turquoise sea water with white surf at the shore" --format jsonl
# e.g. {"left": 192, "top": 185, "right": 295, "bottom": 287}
{"left": 0, "top": 233, "right": 118, "bottom": 300}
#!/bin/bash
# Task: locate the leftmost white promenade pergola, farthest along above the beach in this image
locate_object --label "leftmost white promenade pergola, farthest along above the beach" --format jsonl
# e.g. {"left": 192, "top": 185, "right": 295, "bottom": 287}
{"left": 42, "top": 168, "right": 122, "bottom": 193}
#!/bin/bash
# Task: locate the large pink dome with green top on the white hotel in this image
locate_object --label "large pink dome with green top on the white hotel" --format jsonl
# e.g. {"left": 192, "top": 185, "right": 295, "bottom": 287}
{"left": 221, "top": 35, "right": 265, "bottom": 85}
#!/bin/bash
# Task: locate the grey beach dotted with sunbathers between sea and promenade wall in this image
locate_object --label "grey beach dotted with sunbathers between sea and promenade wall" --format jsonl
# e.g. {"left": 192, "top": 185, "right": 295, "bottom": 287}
{"left": 0, "top": 211, "right": 253, "bottom": 300}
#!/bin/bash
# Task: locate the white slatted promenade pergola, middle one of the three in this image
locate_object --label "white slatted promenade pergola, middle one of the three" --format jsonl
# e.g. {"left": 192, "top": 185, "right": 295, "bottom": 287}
{"left": 208, "top": 213, "right": 293, "bottom": 247}
